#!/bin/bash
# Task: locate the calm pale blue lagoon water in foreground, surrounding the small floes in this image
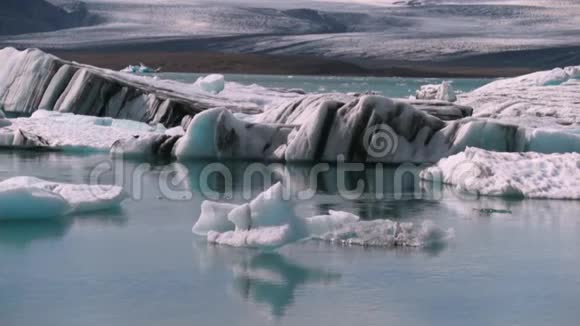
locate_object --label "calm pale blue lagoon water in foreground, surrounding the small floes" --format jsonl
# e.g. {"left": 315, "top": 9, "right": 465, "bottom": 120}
{"left": 0, "top": 77, "right": 580, "bottom": 326}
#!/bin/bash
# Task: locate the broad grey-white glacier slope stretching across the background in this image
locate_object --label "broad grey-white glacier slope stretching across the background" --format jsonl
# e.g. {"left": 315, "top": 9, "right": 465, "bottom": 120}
{"left": 0, "top": 0, "right": 580, "bottom": 74}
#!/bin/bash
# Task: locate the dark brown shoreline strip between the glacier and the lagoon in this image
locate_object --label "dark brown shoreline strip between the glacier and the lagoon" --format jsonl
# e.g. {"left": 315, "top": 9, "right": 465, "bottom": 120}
{"left": 47, "top": 50, "right": 535, "bottom": 78}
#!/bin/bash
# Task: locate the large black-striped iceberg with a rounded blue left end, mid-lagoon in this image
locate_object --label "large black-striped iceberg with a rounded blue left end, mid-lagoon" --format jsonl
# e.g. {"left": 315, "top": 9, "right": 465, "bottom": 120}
{"left": 167, "top": 95, "right": 580, "bottom": 163}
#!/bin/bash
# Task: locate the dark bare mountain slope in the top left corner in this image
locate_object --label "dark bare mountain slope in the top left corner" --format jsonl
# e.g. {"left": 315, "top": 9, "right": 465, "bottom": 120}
{"left": 0, "top": 0, "right": 95, "bottom": 35}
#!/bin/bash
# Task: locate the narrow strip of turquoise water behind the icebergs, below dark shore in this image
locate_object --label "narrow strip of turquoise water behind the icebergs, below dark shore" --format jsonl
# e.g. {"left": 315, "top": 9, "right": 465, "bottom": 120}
{"left": 158, "top": 73, "right": 490, "bottom": 97}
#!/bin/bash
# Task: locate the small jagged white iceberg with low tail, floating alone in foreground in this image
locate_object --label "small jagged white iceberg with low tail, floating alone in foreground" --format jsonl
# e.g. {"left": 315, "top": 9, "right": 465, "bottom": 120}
{"left": 192, "top": 183, "right": 453, "bottom": 250}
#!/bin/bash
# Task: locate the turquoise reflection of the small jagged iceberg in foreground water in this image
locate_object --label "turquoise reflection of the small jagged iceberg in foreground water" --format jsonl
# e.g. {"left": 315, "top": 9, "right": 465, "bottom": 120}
{"left": 194, "top": 241, "right": 340, "bottom": 317}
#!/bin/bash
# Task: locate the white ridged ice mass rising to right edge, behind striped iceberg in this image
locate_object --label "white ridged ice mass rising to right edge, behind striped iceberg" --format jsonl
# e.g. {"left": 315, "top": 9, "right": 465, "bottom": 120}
{"left": 458, "top": 66, "right": 580, "bottom": 130}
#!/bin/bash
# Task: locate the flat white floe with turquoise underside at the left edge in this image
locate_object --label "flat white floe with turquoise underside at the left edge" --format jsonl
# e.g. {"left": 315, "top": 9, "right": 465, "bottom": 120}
{"left": 0, "top": 177, "right": 127, "bottom": 220}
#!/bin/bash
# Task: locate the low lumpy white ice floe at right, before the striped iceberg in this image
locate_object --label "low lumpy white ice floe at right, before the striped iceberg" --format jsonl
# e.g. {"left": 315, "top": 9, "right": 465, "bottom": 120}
{"left": 421, "top": 148, "right": 580, "bottom": 200}
